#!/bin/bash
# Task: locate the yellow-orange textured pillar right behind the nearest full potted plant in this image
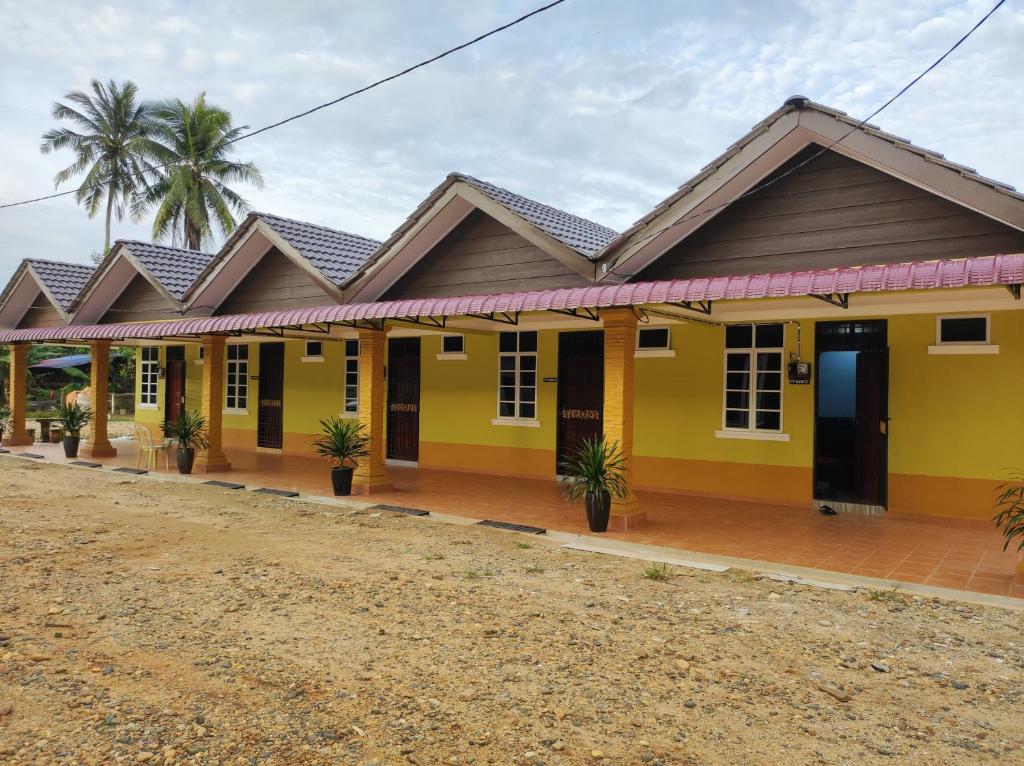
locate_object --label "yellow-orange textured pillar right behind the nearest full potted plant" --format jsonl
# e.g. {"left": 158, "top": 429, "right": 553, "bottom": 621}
{"left": 601, "top": 308, "right": 646, "bottom": 529}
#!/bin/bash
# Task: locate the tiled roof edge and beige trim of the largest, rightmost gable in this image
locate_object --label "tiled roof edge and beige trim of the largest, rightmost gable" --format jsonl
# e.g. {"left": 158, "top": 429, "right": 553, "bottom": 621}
{"left": 598, "top": 96, "right": 1024, "bottom": 279}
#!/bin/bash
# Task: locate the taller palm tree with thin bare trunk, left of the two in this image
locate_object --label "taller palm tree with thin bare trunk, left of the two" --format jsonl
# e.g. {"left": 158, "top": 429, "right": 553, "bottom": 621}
{"left": 39, "top": 80, "right": 153, "bottom": 255}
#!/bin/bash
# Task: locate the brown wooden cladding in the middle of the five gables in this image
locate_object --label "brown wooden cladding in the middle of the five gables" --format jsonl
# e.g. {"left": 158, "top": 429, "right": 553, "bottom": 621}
{"left": 217, "top": 248, "right": 336, "bottom": 314}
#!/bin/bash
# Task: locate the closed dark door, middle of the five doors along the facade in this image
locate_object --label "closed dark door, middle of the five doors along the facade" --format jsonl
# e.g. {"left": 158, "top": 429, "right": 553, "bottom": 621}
{"left": 387, "top": 338, "right": 420, "bottom": 462}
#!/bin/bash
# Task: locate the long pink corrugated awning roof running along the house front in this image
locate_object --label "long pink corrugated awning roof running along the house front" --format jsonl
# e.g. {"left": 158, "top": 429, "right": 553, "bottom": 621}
{"left": 0, "top": 254, "right": 1024, "bottom": 343}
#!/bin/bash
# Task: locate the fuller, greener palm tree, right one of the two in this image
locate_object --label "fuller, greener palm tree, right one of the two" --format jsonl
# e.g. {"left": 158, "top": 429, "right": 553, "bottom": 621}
{"left": 146, "top": 93, "right": 263, "bottom": 250}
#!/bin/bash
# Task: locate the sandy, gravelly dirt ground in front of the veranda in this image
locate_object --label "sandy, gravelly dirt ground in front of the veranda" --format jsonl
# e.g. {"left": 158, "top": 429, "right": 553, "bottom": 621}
{"left": 0, "top": 457, "right": 1024, "bottom": 766}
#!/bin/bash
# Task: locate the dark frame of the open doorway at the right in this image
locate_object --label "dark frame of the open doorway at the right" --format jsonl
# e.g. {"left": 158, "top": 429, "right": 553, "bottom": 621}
{"left": 811, "top": 320, "right": 890, "bottom": 508}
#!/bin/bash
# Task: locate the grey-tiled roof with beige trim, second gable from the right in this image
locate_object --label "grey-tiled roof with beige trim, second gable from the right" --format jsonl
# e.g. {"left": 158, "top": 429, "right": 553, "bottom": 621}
{"left": 345, "top": 173, "right": 616, "bottom": 299}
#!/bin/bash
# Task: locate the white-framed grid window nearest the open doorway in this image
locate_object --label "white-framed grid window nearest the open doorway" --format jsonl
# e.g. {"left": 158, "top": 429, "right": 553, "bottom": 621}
{"left": 723, "top": 325, "right": 785, "bottom": 431}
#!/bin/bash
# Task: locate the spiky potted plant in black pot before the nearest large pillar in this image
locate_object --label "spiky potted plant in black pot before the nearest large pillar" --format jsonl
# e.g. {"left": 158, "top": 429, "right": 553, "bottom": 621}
{"left": 561, "top": 436, "right": 630, "bottom": 531}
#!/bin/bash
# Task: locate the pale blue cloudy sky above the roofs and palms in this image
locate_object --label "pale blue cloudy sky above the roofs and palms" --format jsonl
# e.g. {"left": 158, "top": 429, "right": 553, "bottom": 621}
{"left": 0, "top": 0, "right": 1024, "bottom": 284}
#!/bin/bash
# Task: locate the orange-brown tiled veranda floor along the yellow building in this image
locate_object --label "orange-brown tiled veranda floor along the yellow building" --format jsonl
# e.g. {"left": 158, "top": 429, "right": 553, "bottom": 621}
{"left": 11, "top": 440, "right": 1024, "bottom": 598}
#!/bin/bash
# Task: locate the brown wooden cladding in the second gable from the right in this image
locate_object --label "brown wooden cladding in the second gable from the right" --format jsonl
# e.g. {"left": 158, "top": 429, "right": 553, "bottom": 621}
{"left": 380, "top": 210, "right": 591, "bottom": 300}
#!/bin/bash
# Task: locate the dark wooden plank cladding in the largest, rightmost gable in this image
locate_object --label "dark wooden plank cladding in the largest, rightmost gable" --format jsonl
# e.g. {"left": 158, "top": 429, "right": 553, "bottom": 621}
{"left": 636, "top": 145, "right": 1024, "bottom": 281}
